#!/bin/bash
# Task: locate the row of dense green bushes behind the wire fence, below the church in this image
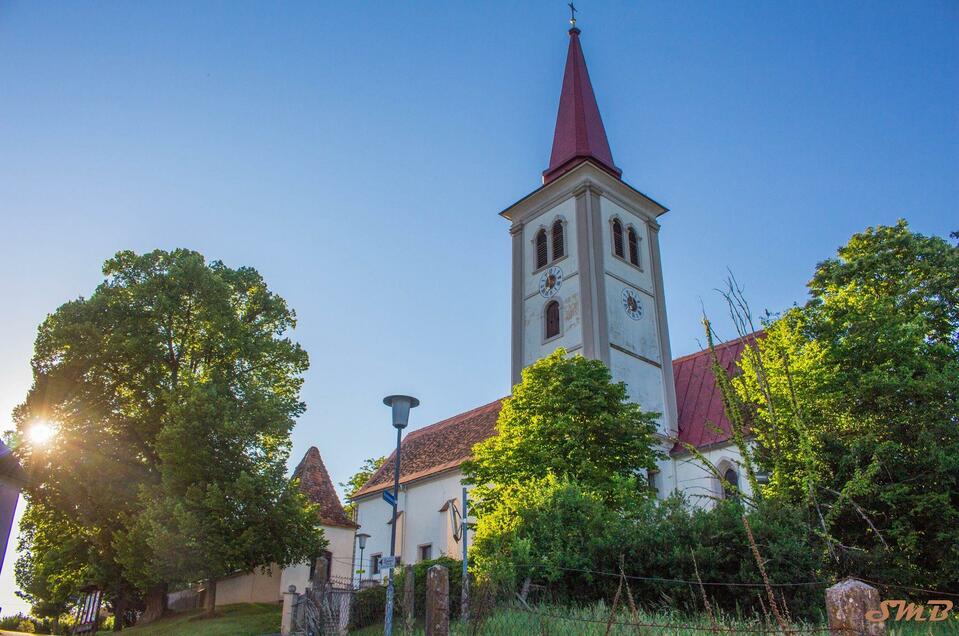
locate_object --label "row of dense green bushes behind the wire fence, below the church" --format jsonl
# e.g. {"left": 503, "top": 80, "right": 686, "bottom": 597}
{"left": 471, "top": 477, "right": 822, "bottom": 617}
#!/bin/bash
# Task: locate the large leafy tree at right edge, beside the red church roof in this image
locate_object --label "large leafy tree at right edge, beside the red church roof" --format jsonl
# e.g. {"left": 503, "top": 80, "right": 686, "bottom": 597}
{"left": 737, "top": 221, "right": 959, "bottom": 588}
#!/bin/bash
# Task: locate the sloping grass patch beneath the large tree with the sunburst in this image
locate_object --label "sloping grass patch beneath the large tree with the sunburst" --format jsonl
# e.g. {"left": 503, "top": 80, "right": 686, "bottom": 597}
{"left": 97, "top": 603, "right": 281, "bottom": 636}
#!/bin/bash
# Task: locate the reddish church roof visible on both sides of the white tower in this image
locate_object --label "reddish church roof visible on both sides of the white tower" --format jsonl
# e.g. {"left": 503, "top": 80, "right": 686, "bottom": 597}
{"left": 354, "top": 334, "right": 757, "bottom": 498}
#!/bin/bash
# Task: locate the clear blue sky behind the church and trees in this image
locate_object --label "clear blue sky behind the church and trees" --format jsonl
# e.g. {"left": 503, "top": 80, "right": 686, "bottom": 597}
{"left": 0, "top": 0, "right": 959, "bottom": 614}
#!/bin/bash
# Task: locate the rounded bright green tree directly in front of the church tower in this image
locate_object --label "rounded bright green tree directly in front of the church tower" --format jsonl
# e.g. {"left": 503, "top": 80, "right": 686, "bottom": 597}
{"left": 464, "top": 349, "right": 658, "bottom": 517}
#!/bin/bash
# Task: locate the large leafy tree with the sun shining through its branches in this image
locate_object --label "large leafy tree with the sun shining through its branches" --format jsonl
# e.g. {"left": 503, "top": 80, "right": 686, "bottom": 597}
{"left": 14, "top": 250, "right": 322, "bottom": 628}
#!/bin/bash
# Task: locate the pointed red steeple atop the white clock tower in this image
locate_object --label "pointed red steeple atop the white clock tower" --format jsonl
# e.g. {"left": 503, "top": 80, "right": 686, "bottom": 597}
{"left": 543, "top": 26, "right": 623, "bottom": 183}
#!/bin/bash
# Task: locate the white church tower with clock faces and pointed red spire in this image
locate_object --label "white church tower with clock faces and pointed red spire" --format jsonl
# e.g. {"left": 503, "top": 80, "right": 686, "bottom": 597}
{"left": 501, "top": 22, "right": 676, "bottom": 436}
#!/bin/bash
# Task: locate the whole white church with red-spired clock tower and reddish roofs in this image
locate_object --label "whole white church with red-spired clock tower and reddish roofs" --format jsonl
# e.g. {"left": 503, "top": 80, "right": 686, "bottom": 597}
{"left": 346, "top": 21, "right": 749, "bottom": 580}
